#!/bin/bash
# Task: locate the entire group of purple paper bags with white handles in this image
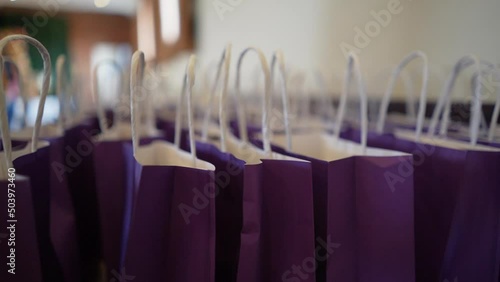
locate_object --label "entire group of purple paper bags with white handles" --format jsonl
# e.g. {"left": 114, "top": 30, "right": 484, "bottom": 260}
{"left": 0, "top": 33, "right": 500, "bottom": 282}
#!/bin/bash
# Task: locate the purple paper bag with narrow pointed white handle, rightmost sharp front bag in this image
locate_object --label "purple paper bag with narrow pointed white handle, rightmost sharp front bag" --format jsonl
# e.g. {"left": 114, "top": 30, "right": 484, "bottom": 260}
{"left": 326, "top": 55, "right": 415, "bottom": 282}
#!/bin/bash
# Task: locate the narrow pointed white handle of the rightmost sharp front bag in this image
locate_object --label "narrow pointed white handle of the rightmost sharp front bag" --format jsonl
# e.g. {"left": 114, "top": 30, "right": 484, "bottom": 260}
{"left": 335, "top": 52, "right": 368, "bottom": 153}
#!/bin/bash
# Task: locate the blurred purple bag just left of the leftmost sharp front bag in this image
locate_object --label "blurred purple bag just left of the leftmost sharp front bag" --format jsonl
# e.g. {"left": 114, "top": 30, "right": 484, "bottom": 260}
{"left": 89, "top": 54, "right": 170, "bottom": 280}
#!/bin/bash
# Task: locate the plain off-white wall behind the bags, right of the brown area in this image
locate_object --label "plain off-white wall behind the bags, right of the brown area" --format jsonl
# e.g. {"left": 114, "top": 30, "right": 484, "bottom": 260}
{"left": 196, "top": 0, "right": 500, "bottom": 103}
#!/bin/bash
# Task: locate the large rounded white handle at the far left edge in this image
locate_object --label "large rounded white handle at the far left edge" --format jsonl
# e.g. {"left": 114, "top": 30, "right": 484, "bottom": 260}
{"left": 0, "top": 34, "right": 52, "bottom": 168}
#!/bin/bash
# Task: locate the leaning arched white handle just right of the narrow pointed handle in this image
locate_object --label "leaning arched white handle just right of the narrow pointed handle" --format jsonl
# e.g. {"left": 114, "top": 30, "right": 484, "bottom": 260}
{"left": 376, "top": 51, "right": 429, "bottom": 140}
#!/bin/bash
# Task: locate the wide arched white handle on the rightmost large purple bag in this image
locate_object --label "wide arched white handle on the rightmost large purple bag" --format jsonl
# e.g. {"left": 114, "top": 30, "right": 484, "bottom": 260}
{"left": 428, "top": 55, "right": 482, "bottom": 145}
